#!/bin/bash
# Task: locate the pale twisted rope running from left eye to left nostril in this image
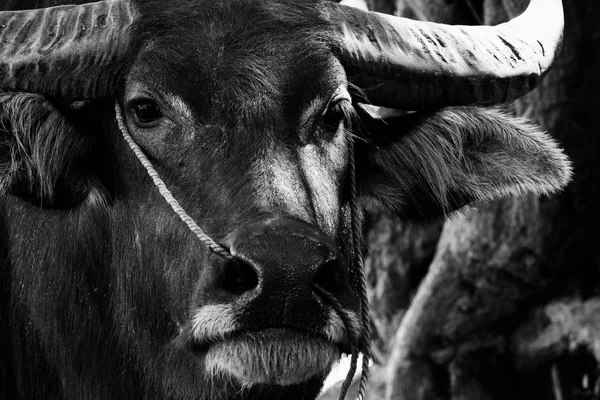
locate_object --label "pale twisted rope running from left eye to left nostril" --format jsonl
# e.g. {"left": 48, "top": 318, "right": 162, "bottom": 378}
{"left": 115, "top": 102, "right": 234, "bottom": 261}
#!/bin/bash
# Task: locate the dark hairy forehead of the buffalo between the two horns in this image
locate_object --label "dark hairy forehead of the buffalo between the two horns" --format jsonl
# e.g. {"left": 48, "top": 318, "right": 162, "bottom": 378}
{"left": 133, "top": 0, "right": 339, "bottom": 130}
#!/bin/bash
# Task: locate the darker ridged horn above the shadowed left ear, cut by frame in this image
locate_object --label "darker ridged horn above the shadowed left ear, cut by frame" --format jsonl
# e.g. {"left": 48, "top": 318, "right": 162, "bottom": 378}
{"left": 0, "top": 0, "right": 136, "bottom": 100}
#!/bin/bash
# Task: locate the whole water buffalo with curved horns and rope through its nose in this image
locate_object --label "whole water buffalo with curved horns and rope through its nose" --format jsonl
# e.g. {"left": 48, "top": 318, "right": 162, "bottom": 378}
{"left": 0, "top": 0, "right": 570, "bottom": 399}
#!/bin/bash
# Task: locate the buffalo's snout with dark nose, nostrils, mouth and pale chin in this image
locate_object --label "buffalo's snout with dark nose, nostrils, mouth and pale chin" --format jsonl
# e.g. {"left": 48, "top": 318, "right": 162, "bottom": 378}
{"left": 185, "top": 218, "right": 360, "bottom": 384}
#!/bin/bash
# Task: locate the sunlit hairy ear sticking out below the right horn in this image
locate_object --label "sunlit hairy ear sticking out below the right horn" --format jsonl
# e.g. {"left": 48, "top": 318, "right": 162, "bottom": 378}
{"left": 356, "top": 106, "right": 571, "bottom": 221}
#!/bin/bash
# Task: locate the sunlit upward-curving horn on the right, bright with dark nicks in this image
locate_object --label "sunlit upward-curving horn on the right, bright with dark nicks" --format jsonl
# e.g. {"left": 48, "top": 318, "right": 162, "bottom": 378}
{"left": 323, "top": 0, "right": 564, "bottom": 109}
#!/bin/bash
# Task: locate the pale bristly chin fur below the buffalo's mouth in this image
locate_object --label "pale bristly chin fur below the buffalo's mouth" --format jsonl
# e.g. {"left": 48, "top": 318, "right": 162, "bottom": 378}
{"left": 205, "top": 329, "right": 341, "bottom": 386}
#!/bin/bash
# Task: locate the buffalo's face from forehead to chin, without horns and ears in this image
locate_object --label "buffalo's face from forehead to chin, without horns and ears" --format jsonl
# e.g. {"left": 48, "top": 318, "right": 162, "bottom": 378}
{"left": 115, "top": 5, "right": 361, "bottom": 386}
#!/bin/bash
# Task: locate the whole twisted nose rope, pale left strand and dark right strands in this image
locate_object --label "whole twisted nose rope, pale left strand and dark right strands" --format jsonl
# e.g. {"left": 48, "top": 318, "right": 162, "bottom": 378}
{"left": 115, "top": 102, "right": 371, "bottom": 400}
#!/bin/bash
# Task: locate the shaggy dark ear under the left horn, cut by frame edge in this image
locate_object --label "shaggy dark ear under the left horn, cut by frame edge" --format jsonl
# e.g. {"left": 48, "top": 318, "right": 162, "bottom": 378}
{"left": 0, "top": 93, "right": 106, "bottom": 208}
